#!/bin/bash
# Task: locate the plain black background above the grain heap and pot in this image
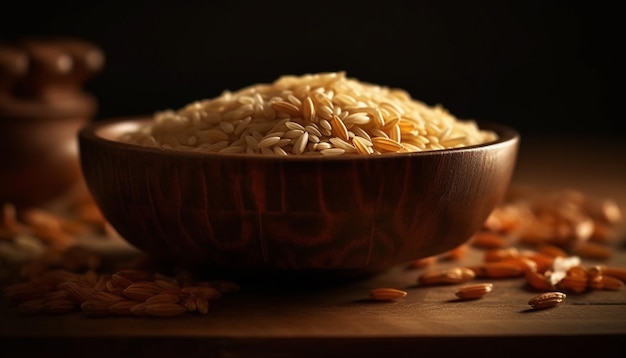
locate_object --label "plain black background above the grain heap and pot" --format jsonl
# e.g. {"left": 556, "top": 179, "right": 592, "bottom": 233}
{"left": 0, "top": 0, "right": 624, "bottom": 136}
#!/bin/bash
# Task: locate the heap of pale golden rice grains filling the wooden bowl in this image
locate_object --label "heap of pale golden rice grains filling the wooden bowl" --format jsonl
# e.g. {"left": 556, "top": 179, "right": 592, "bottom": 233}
{"left": 120, "top": 72, "right": 497, "bottom": 156}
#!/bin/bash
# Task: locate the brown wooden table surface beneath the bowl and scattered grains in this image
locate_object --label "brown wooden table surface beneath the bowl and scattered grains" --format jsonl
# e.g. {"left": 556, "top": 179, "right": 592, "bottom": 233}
{"left": 0, "top": 136, "right": 626, "bottom": 357}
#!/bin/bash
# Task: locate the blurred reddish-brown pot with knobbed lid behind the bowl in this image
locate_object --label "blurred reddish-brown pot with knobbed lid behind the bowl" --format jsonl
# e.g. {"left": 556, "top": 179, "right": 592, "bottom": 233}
{"left": 0, "top": 38, "right": 104, "bottom": 207}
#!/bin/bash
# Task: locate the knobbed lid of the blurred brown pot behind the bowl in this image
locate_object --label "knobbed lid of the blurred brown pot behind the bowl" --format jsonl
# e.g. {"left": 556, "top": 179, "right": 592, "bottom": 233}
{"left": 0, "top": 37, "right": 104, "bottom": 119}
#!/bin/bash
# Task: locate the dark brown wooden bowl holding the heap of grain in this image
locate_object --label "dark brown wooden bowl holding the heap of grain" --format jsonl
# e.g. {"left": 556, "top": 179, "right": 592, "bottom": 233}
{"left": 78, "top": 118, "right": 519, "bottom": 270}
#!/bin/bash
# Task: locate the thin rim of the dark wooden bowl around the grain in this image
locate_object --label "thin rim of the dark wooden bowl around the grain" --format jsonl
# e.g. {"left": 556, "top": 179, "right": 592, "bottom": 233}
{"left": 77, "top": 115, "right": 520, "bottom": 161}
